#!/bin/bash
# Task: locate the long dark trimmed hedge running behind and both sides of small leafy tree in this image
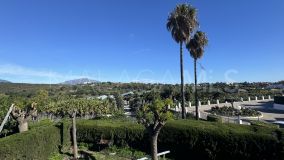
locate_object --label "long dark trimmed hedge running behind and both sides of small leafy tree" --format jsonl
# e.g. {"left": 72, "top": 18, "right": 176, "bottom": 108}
{"left": 77, "top": 120, "right": 284, "bottom": 160}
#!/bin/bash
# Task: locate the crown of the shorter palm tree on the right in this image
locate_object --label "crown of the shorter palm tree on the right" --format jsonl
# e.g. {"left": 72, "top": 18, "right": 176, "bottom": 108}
{"left": 186, "top": 31, "right": 208, "bottom": 59}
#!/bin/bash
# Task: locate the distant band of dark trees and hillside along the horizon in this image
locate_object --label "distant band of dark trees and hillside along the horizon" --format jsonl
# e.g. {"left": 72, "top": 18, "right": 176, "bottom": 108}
{"left": 0, "top": 82, "right": 284, "bottom": 110}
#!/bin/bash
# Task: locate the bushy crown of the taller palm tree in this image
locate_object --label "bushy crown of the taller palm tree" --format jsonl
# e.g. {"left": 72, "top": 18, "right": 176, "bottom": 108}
{"left": 167, "top": 4, "right": 198, "bottom": 43}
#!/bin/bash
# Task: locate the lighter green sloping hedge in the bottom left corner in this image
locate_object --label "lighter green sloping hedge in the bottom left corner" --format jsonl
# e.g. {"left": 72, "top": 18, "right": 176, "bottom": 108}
{"left": 0, "top": 123, "right": 61, "bottom": 160}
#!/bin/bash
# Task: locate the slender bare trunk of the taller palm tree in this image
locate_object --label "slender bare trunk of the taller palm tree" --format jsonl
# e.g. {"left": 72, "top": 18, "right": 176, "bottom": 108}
{"left": 180, "top": 42, "right": 186, "bottom": 119}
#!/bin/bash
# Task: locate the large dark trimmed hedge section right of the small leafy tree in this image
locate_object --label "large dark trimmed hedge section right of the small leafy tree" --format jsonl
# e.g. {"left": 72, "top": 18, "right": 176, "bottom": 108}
{"left": 159, "top": 121, "right": 283, "bottom": 160}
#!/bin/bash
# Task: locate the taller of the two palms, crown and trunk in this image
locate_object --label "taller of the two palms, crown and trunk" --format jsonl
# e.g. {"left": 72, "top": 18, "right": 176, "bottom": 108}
{"left": 167, "top": 4, "right": 198, "bottom": 118}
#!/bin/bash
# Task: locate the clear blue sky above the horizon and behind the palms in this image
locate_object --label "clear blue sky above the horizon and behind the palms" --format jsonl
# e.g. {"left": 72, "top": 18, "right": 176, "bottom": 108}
{"left": 0, "top": 0, "right": 284, "bottom": 83}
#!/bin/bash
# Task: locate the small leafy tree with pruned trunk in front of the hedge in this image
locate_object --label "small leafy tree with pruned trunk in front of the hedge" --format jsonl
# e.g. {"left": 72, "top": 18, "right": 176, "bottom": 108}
{"left": 136, "top": 99, "right": 173, "bottom": 160}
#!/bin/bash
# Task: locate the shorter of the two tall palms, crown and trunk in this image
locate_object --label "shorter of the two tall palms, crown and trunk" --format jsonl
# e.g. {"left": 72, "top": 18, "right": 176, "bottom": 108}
{"left": 186, "top": 31, "right": 208, "bottom": 120}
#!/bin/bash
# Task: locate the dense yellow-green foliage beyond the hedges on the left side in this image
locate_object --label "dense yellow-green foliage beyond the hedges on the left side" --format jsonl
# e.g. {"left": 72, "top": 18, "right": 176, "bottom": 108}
{"left": 0, "top": 90, "right": 118, "bottom": 137}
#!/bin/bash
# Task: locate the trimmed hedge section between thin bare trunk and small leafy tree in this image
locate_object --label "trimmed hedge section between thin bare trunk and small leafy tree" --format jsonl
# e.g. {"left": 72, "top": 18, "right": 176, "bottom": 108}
{"left": 77, "top": 120, "right": 148, "bottom": 150}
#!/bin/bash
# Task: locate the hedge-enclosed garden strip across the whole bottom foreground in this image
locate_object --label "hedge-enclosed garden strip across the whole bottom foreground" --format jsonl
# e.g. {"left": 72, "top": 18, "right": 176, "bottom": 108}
{"left": 0, "top": 119, "right": 284, "bottom": 160}
